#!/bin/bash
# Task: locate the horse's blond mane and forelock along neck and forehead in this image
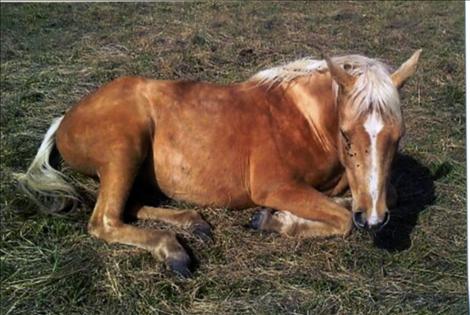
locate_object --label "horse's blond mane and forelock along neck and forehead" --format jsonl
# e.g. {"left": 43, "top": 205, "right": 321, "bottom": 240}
{"left": 250, "top": 55, "right": 401, "bottom": 120}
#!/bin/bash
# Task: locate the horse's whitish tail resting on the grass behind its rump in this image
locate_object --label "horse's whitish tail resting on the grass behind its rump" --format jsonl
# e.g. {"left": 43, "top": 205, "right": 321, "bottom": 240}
{"left": 14, "top": 116, "right": 79, "bottom": 213}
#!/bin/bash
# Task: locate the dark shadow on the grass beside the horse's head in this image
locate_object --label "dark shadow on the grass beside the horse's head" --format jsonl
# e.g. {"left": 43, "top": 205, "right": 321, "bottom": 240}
{"left": 374, "top": 154, "right": 444, "bottom": 251}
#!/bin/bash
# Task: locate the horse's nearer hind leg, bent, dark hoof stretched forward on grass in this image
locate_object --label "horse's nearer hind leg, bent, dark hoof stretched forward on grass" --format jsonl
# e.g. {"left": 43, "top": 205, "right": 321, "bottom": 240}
{"left": 88, "top": 159, "right": 190, "bottom": 276}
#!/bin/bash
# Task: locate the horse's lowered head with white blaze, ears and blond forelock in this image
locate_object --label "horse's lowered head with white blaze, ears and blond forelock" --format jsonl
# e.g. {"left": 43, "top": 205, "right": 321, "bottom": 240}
{"left": 325, "top": 50, "right": 421, "bottom": 230}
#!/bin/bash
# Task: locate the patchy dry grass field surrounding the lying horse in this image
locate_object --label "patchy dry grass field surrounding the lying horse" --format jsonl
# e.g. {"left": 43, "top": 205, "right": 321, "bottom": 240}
{"left": 0, "top": 2, "right": 468, "bottom": 314}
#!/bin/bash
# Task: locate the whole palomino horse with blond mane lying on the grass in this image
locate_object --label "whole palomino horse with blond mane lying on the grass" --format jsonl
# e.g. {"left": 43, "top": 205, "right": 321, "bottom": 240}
{"left": 18, "top": 50, "right": 421, "bottom": 276}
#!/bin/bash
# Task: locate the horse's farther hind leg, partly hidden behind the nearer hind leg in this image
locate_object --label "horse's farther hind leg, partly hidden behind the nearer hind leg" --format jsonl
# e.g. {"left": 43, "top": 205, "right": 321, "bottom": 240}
{"left": 129, "top": 206, "right": 212, "bottom": 239}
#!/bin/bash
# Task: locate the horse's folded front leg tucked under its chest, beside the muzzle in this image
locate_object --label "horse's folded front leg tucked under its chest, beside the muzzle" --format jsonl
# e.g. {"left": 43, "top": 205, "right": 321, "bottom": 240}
{"left": 251, "top": 182, "right": 352, "bottom": 237}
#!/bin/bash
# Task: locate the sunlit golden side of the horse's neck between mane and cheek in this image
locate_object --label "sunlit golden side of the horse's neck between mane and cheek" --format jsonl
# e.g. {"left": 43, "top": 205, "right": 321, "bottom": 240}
{"left": 287, "top": 73, "right": 338, "bottom": 151}
